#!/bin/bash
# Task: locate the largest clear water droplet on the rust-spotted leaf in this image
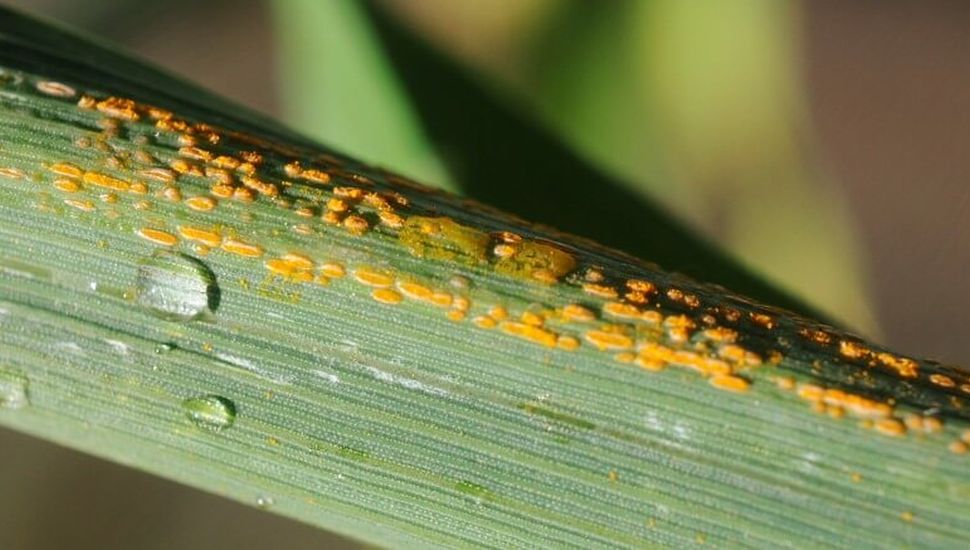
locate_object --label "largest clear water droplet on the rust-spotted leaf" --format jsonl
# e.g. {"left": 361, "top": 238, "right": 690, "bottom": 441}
{"left": 136, "top": 250, "right": 219, "bottom": 321}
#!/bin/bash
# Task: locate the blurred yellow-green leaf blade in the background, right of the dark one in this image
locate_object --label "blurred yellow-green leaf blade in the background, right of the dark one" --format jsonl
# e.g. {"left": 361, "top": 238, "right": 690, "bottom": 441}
{"left": 640, "top": 0, "right": 876, "bottom": 333}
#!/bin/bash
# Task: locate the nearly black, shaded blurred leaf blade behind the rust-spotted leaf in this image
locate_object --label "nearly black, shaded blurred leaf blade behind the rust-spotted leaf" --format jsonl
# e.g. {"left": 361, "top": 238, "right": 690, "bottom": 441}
{"left": 368, "top": 4, "right": 832, "bottom": 324}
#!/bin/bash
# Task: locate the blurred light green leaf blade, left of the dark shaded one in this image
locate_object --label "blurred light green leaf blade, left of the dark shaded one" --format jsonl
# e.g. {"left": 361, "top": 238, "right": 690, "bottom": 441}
{"left": 273, "top": 0, "right": 454, "bottom": 190}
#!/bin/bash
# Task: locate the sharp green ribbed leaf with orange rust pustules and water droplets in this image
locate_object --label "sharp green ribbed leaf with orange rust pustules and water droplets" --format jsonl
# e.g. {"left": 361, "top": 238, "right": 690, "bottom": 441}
{"left": 0, "top": 8, "right": 970, "bottom": 548}
